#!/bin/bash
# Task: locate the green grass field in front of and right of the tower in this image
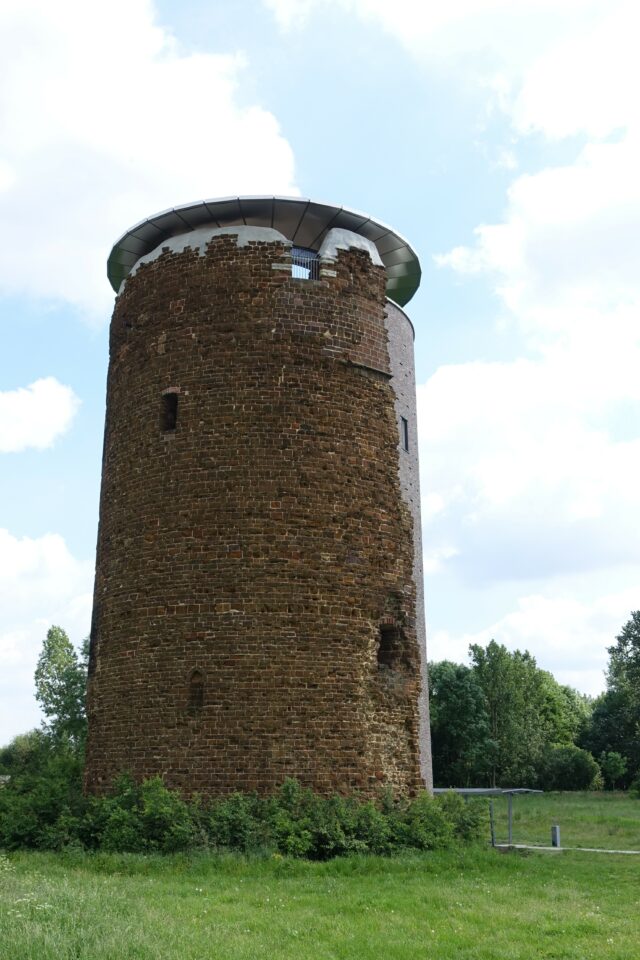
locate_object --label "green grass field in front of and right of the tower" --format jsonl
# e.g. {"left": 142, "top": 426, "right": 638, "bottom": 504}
{"left": 0, "top": 795, "right": 640, "bottom": 960}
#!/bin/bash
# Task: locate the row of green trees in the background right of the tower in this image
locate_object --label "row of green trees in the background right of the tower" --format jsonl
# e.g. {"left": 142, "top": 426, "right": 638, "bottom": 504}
{"left": 429, "top": 611, "right": 640, "bottom": 790}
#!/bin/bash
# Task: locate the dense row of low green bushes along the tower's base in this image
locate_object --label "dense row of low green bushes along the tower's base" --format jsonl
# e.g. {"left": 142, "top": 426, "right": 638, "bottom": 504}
{"left": 0, "top": 775, "right": 488, "bottom": 860}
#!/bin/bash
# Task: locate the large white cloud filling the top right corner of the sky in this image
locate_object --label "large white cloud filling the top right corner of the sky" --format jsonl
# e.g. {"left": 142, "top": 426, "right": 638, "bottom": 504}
{"left": 263, "top": 0, "right": 639, "bottom": 160}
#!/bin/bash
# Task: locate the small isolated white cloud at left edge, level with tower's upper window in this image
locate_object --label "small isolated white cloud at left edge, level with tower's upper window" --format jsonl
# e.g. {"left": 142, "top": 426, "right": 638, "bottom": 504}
{"left": 0, "top": 377, "right": 80, "bottom": 453}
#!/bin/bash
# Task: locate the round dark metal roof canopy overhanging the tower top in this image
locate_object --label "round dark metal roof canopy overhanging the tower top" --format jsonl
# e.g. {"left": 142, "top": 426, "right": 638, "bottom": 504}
{"left": 107, "top": 197, "right": 421, "bottom": 307}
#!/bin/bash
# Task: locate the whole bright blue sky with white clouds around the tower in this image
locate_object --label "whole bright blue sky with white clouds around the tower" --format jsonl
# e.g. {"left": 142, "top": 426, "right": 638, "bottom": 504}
{"left": 0, "top": 0, "right": 640, "bottom": 743}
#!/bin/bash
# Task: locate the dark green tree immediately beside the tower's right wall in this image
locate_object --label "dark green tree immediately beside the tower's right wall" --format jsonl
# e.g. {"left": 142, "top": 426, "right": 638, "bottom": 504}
{"left": 429, "top": 660, "right": 496, "bottom": 787}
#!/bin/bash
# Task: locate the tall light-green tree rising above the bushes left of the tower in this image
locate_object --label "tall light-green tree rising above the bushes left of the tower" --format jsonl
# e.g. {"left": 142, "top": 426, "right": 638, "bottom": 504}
{"left": 35, "top": 626, "right": 88, "bottom": 745}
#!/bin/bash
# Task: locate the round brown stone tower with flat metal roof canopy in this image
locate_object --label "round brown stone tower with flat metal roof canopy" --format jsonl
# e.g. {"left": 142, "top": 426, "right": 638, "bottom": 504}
{"left": 86, "top": 197, "right": 431, "bottom": 795}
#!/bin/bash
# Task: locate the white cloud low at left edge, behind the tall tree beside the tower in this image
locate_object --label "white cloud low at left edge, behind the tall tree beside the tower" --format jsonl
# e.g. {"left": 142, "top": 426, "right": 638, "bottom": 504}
{"left": 0, "top": 529, "right": 93, "bottom": 744}
